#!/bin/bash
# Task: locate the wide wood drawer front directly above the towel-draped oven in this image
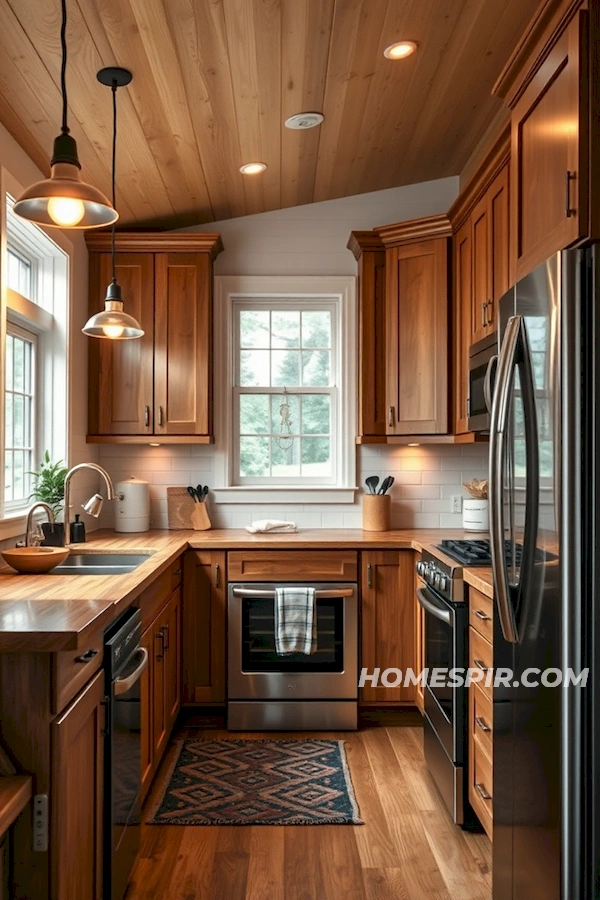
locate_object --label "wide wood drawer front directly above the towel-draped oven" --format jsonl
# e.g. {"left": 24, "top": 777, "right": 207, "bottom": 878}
{"left": 227, "top": 550, "right": 358, "bottom": 582}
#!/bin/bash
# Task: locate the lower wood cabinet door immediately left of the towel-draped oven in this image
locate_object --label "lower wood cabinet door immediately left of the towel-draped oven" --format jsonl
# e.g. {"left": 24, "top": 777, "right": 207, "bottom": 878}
{"left": 183, "top": 551, "right": 227, "bottom": 703}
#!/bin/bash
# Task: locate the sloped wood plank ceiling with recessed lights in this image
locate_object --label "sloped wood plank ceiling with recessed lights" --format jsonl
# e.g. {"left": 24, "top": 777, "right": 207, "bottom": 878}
{"left": 0, "top": 0, "right": 538, "bottom": 227}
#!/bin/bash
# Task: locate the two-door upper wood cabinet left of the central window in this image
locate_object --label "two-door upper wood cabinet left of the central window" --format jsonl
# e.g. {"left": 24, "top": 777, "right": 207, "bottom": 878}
{"left": 86, "top": 233, "right": 222, "bottom": 443}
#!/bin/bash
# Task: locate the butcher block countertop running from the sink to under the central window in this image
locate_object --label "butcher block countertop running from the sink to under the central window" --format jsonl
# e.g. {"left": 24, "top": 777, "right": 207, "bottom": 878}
{"left": 0, "top": 528, "right": 485, "bottom": 652}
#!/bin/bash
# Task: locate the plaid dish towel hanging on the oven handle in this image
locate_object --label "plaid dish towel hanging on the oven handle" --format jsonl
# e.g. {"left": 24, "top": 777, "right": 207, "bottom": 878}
{"left": 275, "top": 587, "right": 317, "bottom": 656}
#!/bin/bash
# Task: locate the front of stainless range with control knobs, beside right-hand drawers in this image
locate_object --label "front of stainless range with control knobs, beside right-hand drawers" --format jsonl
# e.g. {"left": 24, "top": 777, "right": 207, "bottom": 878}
{"left": 417, "top": 553, "right": 468, "bottom": 825}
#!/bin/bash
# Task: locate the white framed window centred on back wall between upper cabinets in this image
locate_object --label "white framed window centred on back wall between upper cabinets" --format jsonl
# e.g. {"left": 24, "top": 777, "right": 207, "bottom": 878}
{"left": 214, "top": 276, "right": 356, "bottom": 504}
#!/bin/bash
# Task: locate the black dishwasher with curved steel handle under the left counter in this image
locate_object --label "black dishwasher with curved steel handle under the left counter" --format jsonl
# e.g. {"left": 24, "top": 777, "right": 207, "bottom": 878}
{"left": 103, "top": 609, "right": 148, "bottom": 900}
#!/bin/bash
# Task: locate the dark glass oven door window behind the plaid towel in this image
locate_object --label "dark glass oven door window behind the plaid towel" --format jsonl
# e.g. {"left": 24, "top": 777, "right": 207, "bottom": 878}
{"left": 242, "top": 598, "right": 344, "bottom": 672}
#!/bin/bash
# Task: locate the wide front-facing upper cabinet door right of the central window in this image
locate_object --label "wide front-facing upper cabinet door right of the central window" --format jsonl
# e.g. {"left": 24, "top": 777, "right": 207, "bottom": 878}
{"left": 386, "top": 238, "right": 449, "bottom": 434}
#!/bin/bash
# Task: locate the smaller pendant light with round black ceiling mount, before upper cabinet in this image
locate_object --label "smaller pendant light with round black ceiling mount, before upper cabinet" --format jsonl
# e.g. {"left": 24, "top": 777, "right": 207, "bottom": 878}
{"left": 82, "top": 66, "right": 144, "bottom": 341}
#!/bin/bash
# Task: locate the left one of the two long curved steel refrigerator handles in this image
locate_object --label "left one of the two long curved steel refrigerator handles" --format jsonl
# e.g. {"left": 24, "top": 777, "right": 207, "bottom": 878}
{"left": 490, "top": 316, "right": 522, "bottom": 644}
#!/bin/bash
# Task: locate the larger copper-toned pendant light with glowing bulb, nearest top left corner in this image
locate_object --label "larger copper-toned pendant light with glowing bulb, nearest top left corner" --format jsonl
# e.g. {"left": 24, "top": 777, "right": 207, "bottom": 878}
{"left": 14, "top": 0, "right": 119, "bottom": 228}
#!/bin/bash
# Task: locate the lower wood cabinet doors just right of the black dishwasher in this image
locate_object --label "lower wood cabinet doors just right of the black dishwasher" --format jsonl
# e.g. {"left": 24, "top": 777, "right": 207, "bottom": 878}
{"left": 141, "top": 588, "right": 181, "bottom": 798}
